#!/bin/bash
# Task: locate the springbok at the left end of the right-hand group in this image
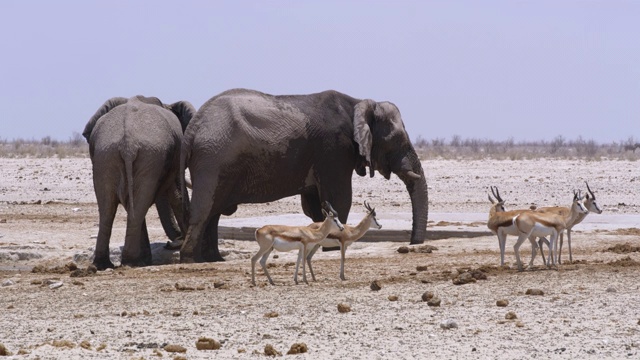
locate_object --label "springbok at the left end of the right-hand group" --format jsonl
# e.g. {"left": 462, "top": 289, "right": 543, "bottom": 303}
{"left": 487, "top": 186, "right": 538, "bottom": 268}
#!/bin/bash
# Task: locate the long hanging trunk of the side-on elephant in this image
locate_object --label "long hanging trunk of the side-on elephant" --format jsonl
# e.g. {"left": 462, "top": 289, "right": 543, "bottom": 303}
{"left": 395, "top": 151, "right": 429, "bottom": 245}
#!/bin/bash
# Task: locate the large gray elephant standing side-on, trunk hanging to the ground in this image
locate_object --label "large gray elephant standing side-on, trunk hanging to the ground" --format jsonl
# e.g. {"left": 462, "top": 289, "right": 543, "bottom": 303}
{"left": 180, "top": 89, "right": 428, "bottom": 262}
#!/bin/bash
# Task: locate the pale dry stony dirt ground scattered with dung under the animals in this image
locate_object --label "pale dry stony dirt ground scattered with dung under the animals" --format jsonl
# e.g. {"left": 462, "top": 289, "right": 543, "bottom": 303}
{"left": 0, "top": 158, "right": 640, "bottom": 359}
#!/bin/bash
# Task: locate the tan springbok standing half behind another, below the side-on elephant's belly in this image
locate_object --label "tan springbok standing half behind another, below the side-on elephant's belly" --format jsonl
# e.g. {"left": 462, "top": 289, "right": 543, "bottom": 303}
{"left": 307, "top": 201, "right": 382, "bottom": 281}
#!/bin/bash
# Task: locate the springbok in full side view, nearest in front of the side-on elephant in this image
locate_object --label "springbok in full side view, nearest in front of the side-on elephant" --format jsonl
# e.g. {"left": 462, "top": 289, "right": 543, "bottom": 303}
{"left": 251, "top": 201, "right": 344, "bottom": 286}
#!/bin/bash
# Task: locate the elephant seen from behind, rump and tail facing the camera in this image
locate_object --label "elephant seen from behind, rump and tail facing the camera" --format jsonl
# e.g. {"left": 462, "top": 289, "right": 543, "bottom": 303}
{"left": 82, "top": 95, "right": 195, "bottom": 270}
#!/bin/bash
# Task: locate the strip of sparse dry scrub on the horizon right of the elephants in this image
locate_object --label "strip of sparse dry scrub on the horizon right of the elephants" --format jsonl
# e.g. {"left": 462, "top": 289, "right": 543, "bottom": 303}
{"left": 414, "top": 135, "right": 640, "bottom": 161}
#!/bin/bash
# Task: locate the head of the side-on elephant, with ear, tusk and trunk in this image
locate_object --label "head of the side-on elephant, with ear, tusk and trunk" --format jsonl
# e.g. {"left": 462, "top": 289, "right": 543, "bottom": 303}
{"left": 353, "top": 99, "right": 429, "bottom": 244}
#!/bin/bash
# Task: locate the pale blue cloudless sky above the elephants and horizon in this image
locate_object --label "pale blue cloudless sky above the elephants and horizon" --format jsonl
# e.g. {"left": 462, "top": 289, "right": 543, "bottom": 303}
{"left": 0, "top": 0, "right": 640, "bottom": 142}
